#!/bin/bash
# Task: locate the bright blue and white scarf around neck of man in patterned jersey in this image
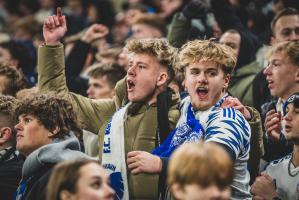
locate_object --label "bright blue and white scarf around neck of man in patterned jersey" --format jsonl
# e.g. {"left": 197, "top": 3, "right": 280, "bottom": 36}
{"left": 152, "top": 95, "right": 227, "bottom": 157}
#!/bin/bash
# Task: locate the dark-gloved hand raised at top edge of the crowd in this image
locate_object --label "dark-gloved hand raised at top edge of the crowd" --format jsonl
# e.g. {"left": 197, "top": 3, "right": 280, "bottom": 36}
{"left": 182, "top": 0, "right": 208, "bottom": 19}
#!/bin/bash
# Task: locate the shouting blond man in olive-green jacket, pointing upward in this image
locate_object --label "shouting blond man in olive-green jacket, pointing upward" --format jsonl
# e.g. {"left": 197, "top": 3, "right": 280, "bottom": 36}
{"left": 38, "top": 8, "right": 179, "bottom": 199}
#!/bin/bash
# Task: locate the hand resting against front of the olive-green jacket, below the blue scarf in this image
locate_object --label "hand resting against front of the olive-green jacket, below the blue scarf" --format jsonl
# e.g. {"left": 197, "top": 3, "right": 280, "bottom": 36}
{"left": 127, "top": 151, "right": 162, "bottom": 174}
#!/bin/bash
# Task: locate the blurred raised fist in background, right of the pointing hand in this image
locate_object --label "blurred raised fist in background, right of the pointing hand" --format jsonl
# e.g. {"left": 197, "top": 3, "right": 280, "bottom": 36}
{"left": 81, "top": 24, "right": 109, "bottom": 44}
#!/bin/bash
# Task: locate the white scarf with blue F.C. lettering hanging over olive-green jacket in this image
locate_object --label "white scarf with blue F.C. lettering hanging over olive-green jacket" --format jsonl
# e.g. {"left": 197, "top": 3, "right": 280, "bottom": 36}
{"left": 102, "top": 104, "right": 130, "bottom": 200}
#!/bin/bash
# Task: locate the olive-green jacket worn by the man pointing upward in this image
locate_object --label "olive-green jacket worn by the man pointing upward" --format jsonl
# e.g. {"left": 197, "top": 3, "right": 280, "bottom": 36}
{"left": 38, "top": 45, "right": 179, "bottom": 199}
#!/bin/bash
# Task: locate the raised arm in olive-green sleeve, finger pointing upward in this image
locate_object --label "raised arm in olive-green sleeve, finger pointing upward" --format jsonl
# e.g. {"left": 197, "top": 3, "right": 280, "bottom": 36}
{"left": 38, "top": 7, "right": 115, "bottom": 133}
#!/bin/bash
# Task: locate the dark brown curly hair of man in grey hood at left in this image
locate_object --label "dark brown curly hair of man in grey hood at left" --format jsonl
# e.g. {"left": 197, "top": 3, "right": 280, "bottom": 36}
{"left": 16, "top": 93, "right": 82, "bottom": 139}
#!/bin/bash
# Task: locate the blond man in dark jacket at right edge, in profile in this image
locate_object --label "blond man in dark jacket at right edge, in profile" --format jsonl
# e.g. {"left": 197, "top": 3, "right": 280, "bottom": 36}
{"left": 262, "top": 40, "right": 299, "bottom": 162}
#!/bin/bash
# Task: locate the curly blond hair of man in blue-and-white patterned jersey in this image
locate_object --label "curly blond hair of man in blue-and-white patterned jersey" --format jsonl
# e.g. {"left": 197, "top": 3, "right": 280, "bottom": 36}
{"left": 179, "top": 40, "right": 237, "bottom": 74}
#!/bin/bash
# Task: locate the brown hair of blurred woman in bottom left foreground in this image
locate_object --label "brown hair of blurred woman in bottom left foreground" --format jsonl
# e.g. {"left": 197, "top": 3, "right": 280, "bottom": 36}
{"left": 47, "top": 159, "right": 100, "bottom": 200}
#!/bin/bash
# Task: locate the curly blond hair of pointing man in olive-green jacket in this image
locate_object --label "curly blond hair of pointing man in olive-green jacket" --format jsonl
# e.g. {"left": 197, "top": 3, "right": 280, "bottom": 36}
{"left": 125, "top": 38, "right": 177, "bottom": 82}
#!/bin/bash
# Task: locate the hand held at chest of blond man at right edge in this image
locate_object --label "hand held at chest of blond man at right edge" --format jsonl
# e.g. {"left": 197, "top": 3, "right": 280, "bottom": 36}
{"left": 264, "top": 109, "right": 281, "bottom": 141}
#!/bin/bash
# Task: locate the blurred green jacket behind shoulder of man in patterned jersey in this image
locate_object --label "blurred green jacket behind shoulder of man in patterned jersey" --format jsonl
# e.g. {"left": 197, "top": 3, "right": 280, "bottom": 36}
{"left": 228, "top": 61, "right": 262, "bottom": 106}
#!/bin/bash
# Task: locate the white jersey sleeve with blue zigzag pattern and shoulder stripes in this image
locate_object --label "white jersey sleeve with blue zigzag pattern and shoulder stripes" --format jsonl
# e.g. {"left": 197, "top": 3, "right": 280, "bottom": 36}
{"left": 204, "top": 108, "right": 250, "bottom": 160}
